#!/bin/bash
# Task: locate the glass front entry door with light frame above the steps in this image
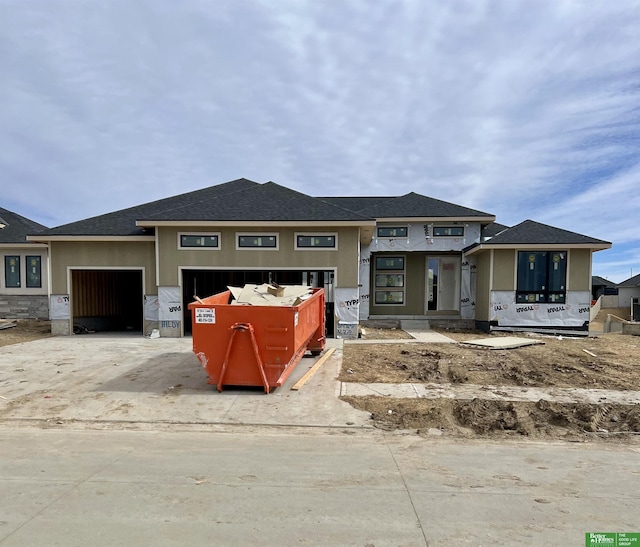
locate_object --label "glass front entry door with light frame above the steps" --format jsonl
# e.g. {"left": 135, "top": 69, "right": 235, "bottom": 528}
{"left": 425, "top": 256, "right": 460, "bottom": 314}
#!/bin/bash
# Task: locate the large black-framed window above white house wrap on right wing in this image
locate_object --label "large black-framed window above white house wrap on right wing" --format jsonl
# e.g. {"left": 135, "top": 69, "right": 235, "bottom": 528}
{"left": 516, "top": 251, "right": 567, "bottom": 304}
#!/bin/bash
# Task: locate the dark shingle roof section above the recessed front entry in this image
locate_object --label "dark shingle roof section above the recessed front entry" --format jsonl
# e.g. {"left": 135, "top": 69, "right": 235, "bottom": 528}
{"left": 320, "top": 192, "right": 493, "bottom": 219}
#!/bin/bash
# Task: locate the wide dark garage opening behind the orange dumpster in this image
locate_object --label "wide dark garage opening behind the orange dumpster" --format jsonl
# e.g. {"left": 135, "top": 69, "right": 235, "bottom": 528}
{"left": 182, "top": 270, "right": 335, "bottom": 337}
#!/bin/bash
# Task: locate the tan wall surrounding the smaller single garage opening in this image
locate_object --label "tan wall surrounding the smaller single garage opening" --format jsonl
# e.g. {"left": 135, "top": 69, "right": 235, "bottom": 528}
{"left": 50, "top": 241, "right": 157, "bottom": 294}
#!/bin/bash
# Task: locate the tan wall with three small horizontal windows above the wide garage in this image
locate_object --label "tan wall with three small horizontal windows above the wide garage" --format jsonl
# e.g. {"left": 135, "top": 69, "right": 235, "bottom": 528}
{"left": 158, "top": 227, "right": 359, "bottom": 287}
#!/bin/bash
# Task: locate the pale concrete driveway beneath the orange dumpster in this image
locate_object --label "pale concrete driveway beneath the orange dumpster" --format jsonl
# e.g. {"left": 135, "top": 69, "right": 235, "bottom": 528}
{"left": 0, "top": 334, "right": 370, "bottom": 427}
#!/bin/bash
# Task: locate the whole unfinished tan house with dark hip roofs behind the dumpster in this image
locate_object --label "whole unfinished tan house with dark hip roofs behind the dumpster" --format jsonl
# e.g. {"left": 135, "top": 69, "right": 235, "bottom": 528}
{"left": 25, "top": 179, "right": 610, "bottom": 336}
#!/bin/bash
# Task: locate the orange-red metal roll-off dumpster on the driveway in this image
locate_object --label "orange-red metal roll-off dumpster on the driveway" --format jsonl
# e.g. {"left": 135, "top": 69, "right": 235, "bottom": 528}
{"left": 189, "top": 289, "right": 326, "bottom": 393}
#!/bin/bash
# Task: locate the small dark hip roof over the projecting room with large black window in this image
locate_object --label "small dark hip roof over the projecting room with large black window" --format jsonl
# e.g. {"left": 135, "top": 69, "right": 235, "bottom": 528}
{"left": 487, "top": 220, "right": 611, "bottom": 245}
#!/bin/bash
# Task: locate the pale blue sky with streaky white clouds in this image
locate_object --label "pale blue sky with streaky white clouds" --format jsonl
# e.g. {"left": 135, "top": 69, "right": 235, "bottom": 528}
{"left": 0, "top": 0, "right": 640, "bottom": 282}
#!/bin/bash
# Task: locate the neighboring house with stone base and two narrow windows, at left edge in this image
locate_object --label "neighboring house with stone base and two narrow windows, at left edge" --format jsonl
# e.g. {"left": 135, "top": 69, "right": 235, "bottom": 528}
{"left": 0, "top": 207, "right": 49, "bottom": 319}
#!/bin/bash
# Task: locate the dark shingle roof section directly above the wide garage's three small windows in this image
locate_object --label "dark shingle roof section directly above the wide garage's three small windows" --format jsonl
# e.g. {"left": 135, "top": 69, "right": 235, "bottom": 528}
{"left": 138, "top": 182, "right": 369, "bottom": 222}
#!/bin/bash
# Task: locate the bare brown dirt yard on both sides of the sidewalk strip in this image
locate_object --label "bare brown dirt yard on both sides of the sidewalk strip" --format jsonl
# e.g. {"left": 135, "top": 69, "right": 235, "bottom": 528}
{"left": 339, "top": 329, "right": 640, "bottom": 440}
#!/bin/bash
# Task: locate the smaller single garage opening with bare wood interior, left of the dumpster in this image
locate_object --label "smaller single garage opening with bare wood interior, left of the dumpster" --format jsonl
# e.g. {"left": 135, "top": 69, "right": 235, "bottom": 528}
{"left": 71, "top": 270, "right": 143, "bottom": 334}
